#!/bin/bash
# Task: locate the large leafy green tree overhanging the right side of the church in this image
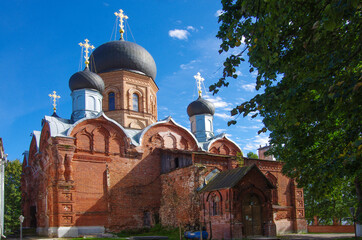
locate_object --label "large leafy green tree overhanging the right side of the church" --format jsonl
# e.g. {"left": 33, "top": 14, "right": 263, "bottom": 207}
{"left": 210, "top": 0, "right": 362, "bottom": 223}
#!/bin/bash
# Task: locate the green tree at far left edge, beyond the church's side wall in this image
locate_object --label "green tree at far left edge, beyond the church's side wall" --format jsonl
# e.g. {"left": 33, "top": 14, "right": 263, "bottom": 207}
{"left": 4, "top": 159, "right": 22, "bottom": 233}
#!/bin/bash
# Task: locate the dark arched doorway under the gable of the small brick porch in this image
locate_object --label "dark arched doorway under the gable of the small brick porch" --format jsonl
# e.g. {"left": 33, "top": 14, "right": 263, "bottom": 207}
{"left": 242, "top": 193, "right": 263, "bottom": 236}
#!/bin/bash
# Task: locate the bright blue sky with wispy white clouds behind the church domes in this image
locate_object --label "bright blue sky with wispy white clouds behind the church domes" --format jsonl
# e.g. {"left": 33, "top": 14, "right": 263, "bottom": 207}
{"left": 0, "top": 0, "right": 268, "bottom": 160}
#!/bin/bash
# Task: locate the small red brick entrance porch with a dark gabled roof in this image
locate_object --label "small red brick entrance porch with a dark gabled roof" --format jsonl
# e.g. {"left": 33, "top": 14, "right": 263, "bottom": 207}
{"left": 200, "top": 165, "right": 276, "bottom": 239}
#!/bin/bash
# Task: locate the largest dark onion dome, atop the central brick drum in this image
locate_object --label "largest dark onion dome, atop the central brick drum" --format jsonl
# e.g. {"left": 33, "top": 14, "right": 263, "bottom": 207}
{"left": 90, "top": 40, "right": 157, "bottom": 80}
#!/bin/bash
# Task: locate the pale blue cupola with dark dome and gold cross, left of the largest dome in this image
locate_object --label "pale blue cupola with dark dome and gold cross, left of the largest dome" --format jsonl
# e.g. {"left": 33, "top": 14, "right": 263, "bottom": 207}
{"left": 69, "top": 39, "right": 104, "bottom": 122}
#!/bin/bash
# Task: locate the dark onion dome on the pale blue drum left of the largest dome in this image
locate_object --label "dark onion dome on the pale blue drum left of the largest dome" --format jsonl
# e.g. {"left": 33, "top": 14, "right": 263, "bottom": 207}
{"left": 69, "top": 68, "right": 104, "bottom": 93}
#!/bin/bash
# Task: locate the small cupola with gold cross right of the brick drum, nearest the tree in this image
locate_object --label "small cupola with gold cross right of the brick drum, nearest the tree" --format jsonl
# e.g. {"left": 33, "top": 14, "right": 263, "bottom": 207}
{"left": 187, "top": 72, "right": 215, "bottom": 142}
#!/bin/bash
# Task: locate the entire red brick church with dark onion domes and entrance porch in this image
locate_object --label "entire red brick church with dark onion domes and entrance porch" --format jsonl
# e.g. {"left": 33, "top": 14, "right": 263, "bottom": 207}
{"left": 21, "top": 9, "right": 306, "bottom": 239}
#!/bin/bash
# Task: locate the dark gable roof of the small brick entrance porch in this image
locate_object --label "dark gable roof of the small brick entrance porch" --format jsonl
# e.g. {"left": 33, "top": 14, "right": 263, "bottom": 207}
{"left": 200, "top": 164, "right": 275, "bottom": 192}
